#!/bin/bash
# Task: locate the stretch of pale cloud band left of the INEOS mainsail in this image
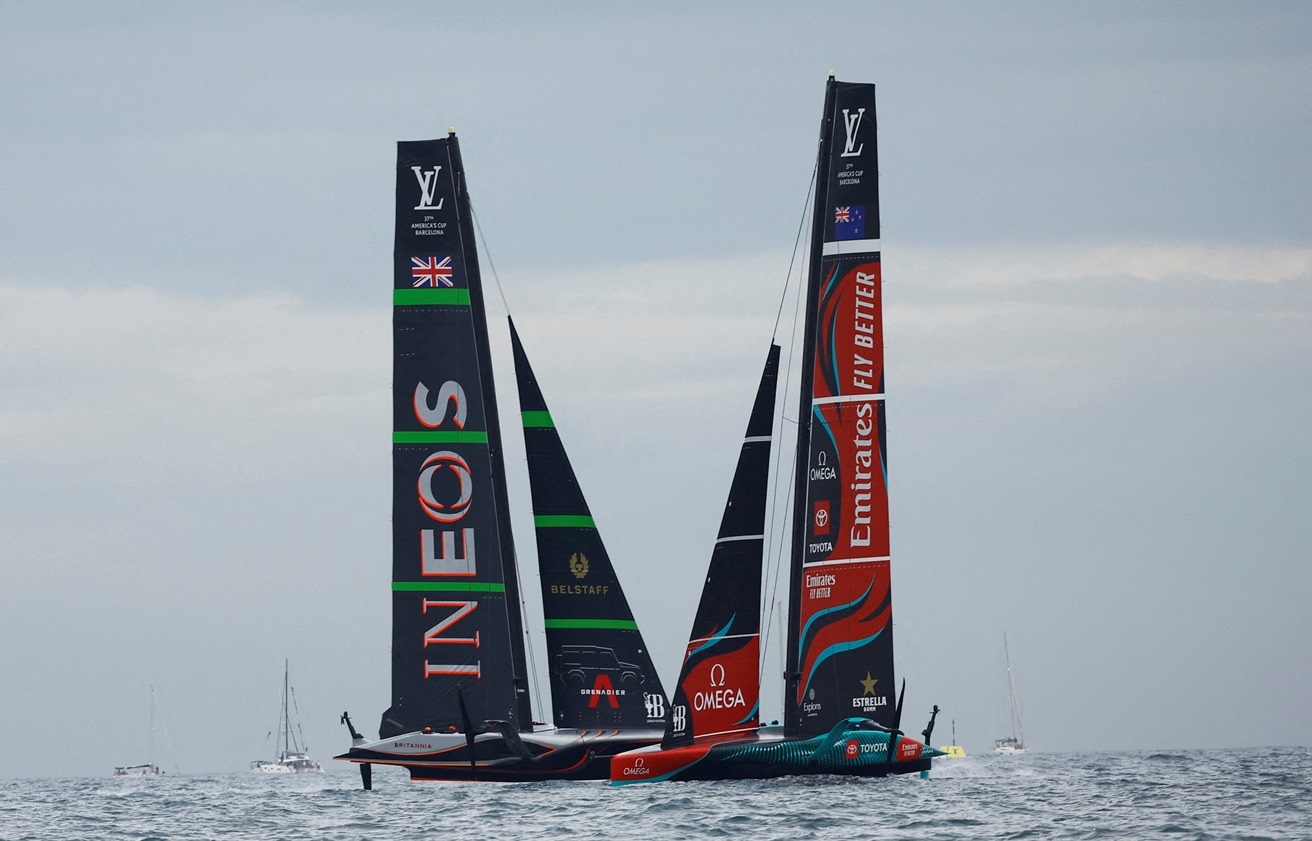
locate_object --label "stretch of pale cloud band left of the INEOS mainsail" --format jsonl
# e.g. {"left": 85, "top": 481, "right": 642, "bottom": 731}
{"left": 0, "top": 283, "right": 390, "bottom": 474}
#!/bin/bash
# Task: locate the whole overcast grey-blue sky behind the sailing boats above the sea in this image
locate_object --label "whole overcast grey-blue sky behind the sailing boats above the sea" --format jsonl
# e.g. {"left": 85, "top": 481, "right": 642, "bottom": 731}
{"left": 0, "top": 0, "right": 1312, "bottom": 777}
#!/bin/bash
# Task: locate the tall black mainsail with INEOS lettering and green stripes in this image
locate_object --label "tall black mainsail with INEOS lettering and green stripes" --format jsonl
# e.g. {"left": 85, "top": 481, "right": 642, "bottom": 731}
{"left": 379, "top": 133, "right": 531, "bottom": 739}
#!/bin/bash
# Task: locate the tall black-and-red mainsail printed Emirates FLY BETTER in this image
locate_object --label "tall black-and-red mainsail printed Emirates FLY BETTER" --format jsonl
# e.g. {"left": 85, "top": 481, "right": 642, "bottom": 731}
{"left": 785, "top": 79, "right": 895, "bottom": 736}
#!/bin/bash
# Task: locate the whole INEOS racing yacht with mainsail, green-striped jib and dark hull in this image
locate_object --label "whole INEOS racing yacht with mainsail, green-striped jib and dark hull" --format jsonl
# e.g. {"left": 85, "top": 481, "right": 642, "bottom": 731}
{"left": 336, "top": 133, "right": 665, "bottom": 789}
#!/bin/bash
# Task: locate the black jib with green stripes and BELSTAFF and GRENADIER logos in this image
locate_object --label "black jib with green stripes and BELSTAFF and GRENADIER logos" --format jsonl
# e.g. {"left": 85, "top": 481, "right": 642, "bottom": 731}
{"left": 510, "top": 321, "right": 665, "bottom": 728}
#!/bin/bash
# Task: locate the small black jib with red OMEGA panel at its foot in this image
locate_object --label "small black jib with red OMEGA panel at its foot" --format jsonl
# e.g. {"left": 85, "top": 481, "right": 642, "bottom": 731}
{"left": 663, "top": 345, "right": 779, "bottom": 747}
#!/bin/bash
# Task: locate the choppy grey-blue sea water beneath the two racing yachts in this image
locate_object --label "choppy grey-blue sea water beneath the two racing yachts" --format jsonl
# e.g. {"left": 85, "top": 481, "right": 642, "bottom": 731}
{"left": 0, "top": 748, "right": 1312, "bottom": 841}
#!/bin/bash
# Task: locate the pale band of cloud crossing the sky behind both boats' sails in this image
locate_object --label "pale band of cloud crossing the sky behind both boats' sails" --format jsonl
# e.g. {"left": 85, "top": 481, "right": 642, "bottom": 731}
{"left": 0, "top": 245, "right": 1312, "bottom": 466}
